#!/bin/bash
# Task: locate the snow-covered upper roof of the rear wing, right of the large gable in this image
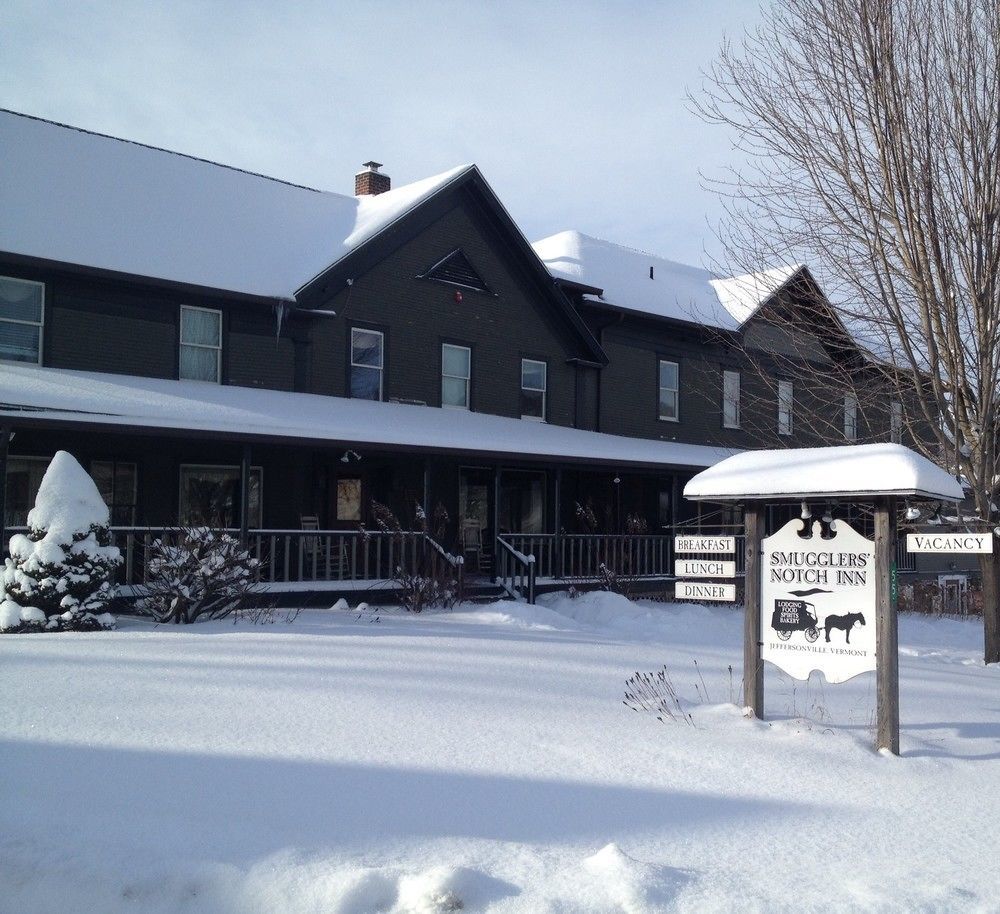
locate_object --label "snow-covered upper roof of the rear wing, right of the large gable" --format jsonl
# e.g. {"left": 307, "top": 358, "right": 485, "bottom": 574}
{"left": 533, "top": 231, "right": 801, "bottom": 330}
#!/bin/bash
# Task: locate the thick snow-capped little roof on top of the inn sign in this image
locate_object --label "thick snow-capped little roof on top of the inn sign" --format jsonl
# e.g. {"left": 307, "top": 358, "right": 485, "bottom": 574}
{"left": 684, "top": 444, "right": 963, "bottom": 501}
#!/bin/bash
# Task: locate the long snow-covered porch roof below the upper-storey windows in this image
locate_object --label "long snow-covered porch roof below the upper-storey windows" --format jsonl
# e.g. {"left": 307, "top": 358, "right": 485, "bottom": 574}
{"left": 0, "top": 365, "right": 734, "bottom": 467}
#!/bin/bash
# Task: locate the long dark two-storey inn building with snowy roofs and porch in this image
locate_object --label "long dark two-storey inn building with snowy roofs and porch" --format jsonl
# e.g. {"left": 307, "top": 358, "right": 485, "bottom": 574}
{"left": 0, "top": 112, "right": 964, "bottom": 592}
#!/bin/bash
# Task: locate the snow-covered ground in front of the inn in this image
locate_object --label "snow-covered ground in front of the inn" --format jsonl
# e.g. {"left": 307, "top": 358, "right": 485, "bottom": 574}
{"left": 0, "top": 594, "right": 1000, "bottom": 914}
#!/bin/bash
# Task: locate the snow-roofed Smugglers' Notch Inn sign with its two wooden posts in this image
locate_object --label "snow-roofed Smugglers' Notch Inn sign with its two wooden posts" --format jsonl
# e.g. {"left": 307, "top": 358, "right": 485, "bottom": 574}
{"left": 684, "top": 444, "right": 962, "bottom": 755}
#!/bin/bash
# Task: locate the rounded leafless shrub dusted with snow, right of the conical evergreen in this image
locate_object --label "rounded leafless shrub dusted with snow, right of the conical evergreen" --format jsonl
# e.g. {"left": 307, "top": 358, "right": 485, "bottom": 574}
{"left": 138, "top": 527, "right": 262, "bottom": 625}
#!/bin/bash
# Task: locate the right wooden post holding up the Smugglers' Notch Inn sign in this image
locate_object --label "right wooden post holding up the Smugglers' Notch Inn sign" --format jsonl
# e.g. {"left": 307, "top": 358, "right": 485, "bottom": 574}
{"left": 875, "top": 496, "right": 899, "bottom": 755}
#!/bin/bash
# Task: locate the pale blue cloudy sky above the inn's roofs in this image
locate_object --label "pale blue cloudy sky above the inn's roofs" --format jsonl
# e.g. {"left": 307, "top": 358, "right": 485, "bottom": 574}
{"left": 0, "top": 0, "right": 758, "bottom": 264}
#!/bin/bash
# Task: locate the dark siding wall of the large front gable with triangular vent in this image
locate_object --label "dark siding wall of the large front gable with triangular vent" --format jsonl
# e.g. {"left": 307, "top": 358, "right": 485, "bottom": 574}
{"left": 299, "top": 205, "right": 581, "bottom": 425}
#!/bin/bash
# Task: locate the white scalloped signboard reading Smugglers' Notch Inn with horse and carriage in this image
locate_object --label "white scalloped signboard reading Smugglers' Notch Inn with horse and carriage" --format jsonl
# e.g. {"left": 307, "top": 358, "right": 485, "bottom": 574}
{"left": 760, "top": 520, "right": 876, "bottom": 682}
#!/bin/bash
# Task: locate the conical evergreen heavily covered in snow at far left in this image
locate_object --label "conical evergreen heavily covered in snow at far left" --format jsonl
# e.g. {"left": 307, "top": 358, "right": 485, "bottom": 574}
{"left": 0, "top": 451, "right": 121, "bottom": 632}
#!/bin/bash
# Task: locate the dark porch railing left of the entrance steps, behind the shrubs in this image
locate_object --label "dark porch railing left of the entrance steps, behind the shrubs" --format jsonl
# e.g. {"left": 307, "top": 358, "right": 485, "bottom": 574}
{"left": 2, "top": 527, "right": 464, "bottom": 592}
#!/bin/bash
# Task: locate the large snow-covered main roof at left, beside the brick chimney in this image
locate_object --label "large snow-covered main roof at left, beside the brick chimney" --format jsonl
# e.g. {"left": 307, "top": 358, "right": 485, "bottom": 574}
{"left": 0, "top": 110, "right": 475, "bottom": 298}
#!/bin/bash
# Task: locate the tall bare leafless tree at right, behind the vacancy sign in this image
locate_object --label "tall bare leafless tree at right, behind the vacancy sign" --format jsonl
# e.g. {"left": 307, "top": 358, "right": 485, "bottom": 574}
{"left": 693, "top": 0, "right": 1000, "bottom": 663}
